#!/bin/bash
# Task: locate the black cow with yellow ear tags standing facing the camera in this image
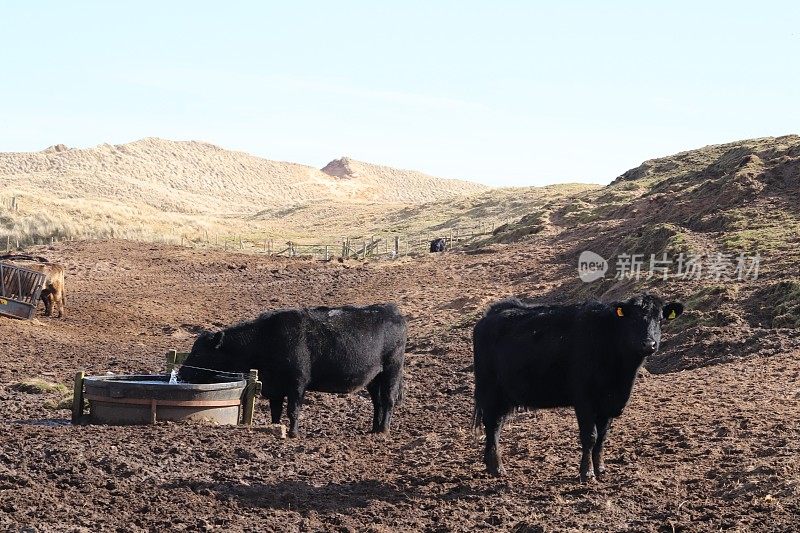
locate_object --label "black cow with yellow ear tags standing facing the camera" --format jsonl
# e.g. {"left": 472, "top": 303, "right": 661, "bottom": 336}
{"left": 473, "top": 295, "right": 683, "bottom": 482}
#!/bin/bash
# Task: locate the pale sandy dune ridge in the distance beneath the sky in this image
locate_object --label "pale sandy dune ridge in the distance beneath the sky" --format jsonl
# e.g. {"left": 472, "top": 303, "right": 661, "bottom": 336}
{"left": 0, "top": 138, "right": 486, "bottom": 214}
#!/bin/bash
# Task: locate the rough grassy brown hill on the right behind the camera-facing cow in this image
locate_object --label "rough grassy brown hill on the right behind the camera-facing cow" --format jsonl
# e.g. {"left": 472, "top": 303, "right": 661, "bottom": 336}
{"left": 482, "top": 135, "right": 800, "bottom": 370}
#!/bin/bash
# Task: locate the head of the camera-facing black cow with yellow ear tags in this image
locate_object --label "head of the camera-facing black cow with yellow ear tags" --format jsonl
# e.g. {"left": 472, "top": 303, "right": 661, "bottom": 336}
{"left": 609, "top": 294, "right": 683, "bottom": 358}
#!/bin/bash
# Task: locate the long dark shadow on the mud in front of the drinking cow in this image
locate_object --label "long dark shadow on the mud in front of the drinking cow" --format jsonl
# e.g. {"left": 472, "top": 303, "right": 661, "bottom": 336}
{"left": 168, "top": 480, "right": 409, "bottom": 513}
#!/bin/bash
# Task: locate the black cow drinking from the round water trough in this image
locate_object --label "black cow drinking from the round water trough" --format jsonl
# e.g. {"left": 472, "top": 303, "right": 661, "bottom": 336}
{"left": 178, "top": 304, "right": 406, "bottom": 437}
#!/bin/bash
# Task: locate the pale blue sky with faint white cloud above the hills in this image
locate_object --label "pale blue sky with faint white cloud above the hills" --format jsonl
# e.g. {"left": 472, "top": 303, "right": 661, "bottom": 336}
{"left": 0, "top": 0, "right": 800, "bottom": 185}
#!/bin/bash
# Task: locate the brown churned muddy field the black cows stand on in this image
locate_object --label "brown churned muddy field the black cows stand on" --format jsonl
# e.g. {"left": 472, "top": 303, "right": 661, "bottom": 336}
{"left": 0, "top": 241, "right": 800, "bottom": 531}
